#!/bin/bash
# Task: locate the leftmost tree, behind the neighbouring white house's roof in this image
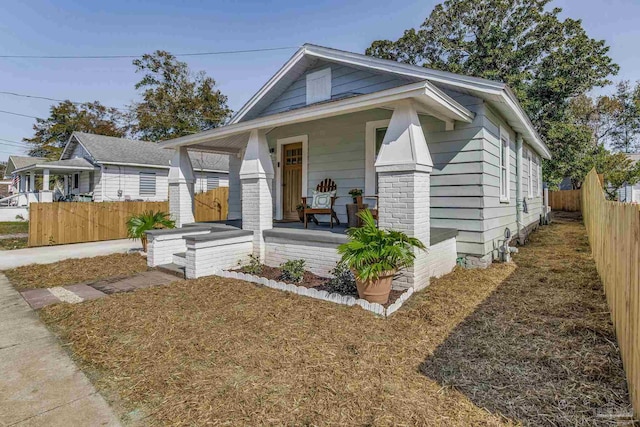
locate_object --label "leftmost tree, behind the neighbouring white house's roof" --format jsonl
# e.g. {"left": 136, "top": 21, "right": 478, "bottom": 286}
{"left": 23, "top": 101, "right": 127, "bottom": 159}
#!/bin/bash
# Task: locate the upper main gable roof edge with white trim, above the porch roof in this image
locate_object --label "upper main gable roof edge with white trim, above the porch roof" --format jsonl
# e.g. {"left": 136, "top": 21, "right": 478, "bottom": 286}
{"left": 230, "top": 44, "right": 551, "bottom": 159}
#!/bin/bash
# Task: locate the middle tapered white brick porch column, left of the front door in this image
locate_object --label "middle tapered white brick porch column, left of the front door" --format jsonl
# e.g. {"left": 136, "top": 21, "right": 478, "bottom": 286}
{"left": 240, "top": 130, "right": 274, "bottom": 262}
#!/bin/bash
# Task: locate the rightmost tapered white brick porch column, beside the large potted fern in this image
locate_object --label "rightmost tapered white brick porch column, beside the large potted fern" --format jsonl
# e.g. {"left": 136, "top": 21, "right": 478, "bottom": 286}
{"left": 375, "top": 100, "right": 433, "bottom": 290}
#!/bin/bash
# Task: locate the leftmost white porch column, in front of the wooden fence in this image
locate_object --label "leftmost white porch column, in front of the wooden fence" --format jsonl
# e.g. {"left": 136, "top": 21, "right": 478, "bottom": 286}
{"left": 168, "top": 147, "right": 195, "bottom": 227}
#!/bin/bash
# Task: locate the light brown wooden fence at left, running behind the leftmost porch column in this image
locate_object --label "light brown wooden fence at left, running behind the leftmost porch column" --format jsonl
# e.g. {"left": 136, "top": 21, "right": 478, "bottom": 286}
{"left": 29, "top": 187, "right": 229, "bottom": 246}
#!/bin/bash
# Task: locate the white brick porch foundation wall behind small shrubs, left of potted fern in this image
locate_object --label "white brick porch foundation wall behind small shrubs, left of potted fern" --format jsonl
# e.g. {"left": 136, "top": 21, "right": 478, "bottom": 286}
{"left": 265, "top": 237, "right": 340, "bottom": 277}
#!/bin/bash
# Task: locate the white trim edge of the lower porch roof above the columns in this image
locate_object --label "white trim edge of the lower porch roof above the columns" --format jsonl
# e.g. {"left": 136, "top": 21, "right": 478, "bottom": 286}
{"left": 158, "top": 82, "right": 475, "bottom": 148}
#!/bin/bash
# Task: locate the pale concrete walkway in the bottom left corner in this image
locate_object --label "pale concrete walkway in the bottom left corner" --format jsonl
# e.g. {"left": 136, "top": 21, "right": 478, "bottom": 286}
{"left": 0, "top": 274, "right": 120, "bottom": 426}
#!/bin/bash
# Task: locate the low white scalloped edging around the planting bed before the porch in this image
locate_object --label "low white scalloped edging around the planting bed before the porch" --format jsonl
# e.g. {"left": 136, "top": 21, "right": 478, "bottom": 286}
{"left": 213, "top": 270, "right": 413, "bottom": 318}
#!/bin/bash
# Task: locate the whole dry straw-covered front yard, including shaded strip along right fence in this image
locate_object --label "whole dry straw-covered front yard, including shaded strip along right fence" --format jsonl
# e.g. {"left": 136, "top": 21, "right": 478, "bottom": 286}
{"left": 40, "top": 217, "right": 629, "bottom": 426}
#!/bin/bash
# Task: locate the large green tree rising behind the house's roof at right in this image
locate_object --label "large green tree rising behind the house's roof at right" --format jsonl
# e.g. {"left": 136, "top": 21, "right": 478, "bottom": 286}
{"left": 366, "top": 0, "right": 618, "bottom": 180}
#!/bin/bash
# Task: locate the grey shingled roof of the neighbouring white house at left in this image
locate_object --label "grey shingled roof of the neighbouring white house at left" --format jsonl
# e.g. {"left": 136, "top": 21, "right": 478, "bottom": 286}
{"left": 60, "top": 132, "right": 229, "bottom": 172}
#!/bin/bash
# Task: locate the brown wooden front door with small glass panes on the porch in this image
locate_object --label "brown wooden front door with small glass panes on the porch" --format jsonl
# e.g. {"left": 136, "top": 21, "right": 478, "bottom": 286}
{"left": 282, "top": 142, "right": 302, "bottom": 220}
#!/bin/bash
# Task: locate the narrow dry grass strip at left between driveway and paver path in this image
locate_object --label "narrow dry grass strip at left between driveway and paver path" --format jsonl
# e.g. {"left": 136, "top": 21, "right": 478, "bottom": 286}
{"left": 3, "top": 253, "right": 147, "bottom": 290}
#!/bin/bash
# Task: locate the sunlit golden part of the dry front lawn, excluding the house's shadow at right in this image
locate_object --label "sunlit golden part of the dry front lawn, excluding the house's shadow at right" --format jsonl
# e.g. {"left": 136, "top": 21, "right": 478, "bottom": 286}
{"left": 40, "top": 216, "right": 632, "bottom": 426}
